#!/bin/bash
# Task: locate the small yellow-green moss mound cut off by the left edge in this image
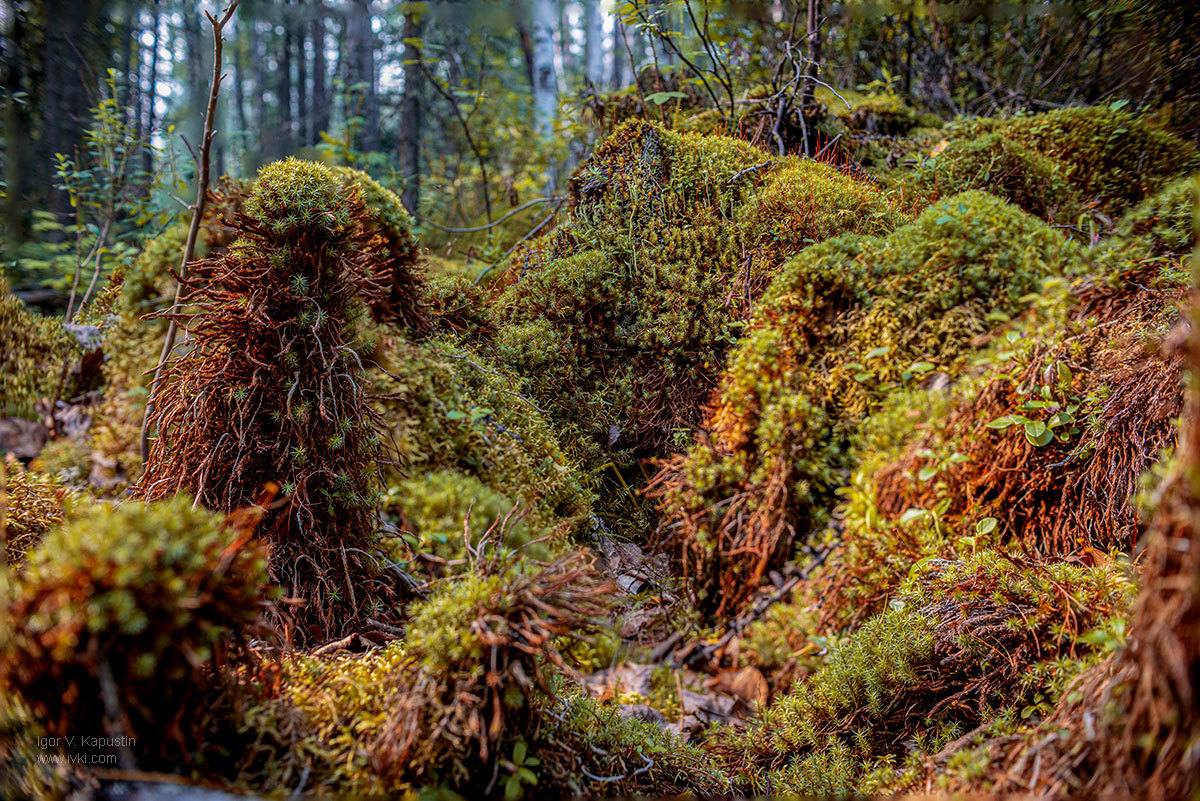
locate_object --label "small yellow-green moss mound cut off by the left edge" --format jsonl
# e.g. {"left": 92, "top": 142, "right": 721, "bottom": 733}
{"left": 0, "top": 276, "right": 82, "bottom": 418}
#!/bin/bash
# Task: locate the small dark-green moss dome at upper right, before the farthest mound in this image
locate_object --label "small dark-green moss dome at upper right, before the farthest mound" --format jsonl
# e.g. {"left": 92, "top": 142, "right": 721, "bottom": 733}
{"left": 912, "top": 133, "right": 1081, "bottom": 222}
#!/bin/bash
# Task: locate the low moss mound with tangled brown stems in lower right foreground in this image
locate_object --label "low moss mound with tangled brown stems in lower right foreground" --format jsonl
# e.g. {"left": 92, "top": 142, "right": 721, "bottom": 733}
{"left": 722, "top": 550, "right": 1133, "bottom": 796}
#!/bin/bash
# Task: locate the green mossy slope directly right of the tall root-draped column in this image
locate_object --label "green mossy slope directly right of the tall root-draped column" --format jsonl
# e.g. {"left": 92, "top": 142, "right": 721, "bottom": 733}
{"left": 378, "top": 338, "right": 590, "bottom": 556}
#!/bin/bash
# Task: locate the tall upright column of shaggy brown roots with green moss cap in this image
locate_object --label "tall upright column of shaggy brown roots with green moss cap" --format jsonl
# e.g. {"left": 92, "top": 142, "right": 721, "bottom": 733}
{"left": 138, "top": 159, "right": 388, "bottom": 637}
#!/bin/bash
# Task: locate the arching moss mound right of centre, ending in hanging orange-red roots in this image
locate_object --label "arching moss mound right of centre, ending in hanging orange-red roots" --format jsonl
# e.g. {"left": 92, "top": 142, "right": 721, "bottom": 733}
{"left": 655, "top": 192, "right": 1078, "bottom": 612}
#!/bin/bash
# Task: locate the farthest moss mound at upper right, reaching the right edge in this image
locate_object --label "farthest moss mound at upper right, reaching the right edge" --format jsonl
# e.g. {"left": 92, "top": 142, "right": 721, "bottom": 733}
{"left": 949, "top": 106, "right": 1200, "bottom": 213}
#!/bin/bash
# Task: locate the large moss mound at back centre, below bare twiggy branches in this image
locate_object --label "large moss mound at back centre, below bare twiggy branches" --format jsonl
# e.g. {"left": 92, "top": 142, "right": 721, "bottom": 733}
{"left": 496, "top": 121, "right": 902, "bottom": 464}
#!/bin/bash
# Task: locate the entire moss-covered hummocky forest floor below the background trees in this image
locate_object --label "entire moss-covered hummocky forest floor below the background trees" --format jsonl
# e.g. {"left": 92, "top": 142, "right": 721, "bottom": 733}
{"left": 0, "top": 82, "right": 1200, "bottom": 800}
